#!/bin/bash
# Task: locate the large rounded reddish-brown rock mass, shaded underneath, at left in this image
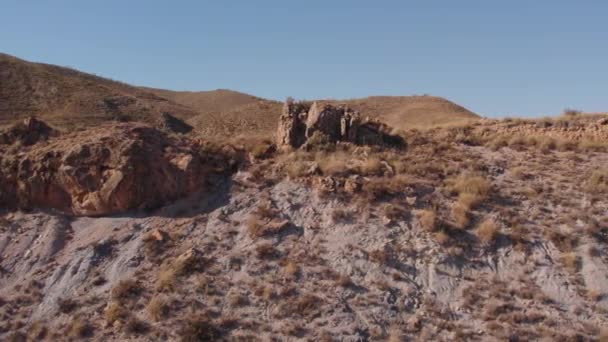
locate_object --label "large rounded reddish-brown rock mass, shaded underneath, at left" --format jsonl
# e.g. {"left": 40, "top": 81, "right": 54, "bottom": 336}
{"left": 0, "top": 123, "right": 216, "bottom": 215}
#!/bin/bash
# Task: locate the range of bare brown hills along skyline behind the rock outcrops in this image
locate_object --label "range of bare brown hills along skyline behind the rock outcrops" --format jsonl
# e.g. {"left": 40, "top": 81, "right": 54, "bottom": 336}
{"left": 0, "top": 54, "right": 478, "bottom": 137}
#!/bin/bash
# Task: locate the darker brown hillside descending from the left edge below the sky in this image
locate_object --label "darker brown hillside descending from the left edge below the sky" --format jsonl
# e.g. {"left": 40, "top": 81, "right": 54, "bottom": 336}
{"left": 0, "top": 54, "right": 195, "bottom": 128}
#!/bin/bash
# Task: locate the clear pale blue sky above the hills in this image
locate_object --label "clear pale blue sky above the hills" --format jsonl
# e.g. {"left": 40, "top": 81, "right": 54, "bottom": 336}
{"left": 0, "top": 0, "right": 608, "bottom": 116}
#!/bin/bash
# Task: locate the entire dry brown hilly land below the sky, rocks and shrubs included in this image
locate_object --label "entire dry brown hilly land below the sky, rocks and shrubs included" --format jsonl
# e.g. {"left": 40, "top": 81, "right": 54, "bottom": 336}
{"left": 0, "top": 55, "right": 608, "bottom": 342}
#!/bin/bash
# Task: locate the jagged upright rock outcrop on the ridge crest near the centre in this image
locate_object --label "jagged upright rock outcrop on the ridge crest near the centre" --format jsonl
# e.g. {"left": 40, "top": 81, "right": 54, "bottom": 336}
{"left": 277, "top": 100, "right": 405, "bottom": 148}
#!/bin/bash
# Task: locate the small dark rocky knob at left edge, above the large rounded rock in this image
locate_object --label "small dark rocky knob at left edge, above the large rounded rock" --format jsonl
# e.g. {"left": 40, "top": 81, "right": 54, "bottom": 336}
{"left": 0, "top": 117, "right": 59, "bottom": 146}
